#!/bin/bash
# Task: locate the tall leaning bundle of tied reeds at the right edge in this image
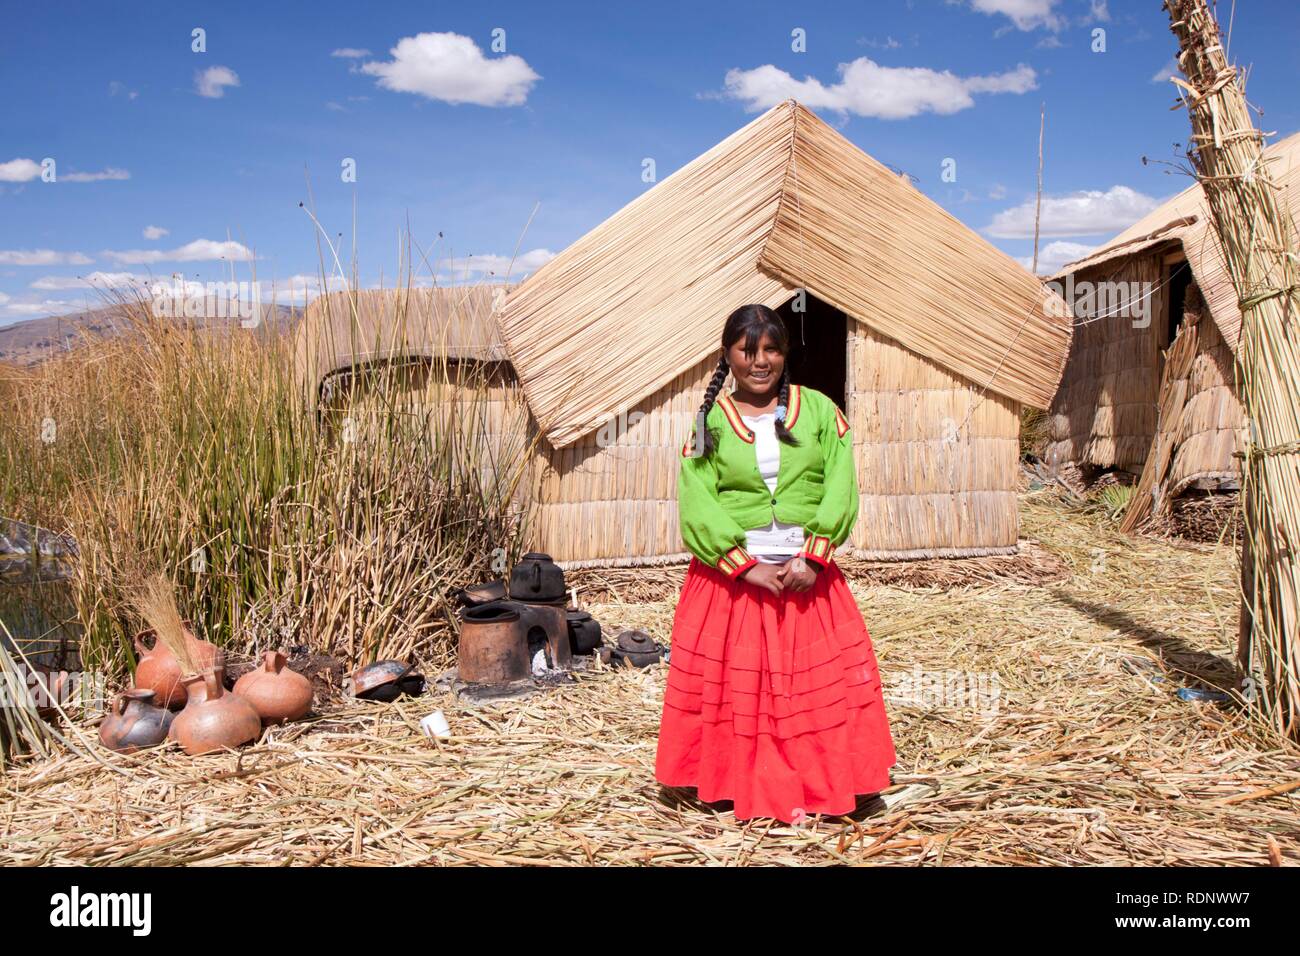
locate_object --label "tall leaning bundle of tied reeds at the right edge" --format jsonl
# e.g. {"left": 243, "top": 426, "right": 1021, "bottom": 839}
{"left": 1165, "top": 0, "right": 1300, "bottom": 736}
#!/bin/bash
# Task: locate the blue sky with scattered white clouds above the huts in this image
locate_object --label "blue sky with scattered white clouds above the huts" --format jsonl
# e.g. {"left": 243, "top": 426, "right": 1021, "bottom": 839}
{"left": 0, "top": 0, "right": 1300, "bottom": 325}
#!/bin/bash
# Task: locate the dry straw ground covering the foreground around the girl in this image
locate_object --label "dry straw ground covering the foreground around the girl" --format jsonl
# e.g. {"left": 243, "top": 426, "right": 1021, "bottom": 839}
{"left": 0, "top": 490, "right": 1300, "bottom": 866}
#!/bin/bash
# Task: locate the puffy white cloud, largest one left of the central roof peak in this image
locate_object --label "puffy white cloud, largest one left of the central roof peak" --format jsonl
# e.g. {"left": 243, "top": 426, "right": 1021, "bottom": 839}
{"left": 361, "top": 33, "right": 541, "bottom": 107}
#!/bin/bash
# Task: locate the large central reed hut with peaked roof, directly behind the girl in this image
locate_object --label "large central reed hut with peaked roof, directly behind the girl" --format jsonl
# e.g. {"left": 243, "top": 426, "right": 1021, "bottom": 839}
{"left": 299, "top": 100, "right": 1070, "bottom": 567}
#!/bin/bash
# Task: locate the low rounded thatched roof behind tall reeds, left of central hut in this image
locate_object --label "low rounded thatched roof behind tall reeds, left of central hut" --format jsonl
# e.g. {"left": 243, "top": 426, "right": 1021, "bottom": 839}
{"left": 294, "top": 285, "right": 508, "bottom": 400}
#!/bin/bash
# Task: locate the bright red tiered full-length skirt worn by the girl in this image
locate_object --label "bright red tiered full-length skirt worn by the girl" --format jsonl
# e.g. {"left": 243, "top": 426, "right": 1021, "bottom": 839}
{"left": 655, "top": 558, "right": 897, "bottom": 823}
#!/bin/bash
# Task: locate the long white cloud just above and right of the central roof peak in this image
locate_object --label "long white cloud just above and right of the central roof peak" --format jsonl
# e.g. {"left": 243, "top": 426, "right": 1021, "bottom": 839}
{"left": 724, "top": 56, "right": 1037, "bottom": 120}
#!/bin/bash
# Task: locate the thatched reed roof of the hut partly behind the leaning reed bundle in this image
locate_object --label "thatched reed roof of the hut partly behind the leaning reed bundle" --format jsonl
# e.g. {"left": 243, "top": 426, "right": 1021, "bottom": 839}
{"left": 1052, "top": 133, "right": 1300, "bottom": 351}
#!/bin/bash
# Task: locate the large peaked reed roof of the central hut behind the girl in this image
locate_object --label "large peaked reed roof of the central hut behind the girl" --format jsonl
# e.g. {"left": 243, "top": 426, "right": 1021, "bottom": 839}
{"left": 499, "top": 100, "right": 1070, "bottom": 446}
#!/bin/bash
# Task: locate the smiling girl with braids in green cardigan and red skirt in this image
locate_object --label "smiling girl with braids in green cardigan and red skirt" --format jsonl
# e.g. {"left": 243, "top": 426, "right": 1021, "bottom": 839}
{"left": 655, "top": 306, "right": 897, "bottom": 823}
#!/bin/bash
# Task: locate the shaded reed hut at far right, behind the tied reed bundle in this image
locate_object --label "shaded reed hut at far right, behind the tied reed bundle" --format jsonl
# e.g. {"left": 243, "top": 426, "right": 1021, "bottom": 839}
{"left": 1045, "top": 134, "right": 1300, "bottom": 507}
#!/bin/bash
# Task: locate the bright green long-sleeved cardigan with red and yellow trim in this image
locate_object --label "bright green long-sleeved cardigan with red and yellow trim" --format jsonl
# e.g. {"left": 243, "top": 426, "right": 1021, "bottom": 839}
{"left": 677, "top": 385, "right": 858, "bottom": 578}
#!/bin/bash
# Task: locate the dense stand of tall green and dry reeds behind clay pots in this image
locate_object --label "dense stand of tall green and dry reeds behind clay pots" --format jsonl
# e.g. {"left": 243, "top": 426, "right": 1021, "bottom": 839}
{"left": 0, "top": 280, "right": 530, "bottom": 675}
